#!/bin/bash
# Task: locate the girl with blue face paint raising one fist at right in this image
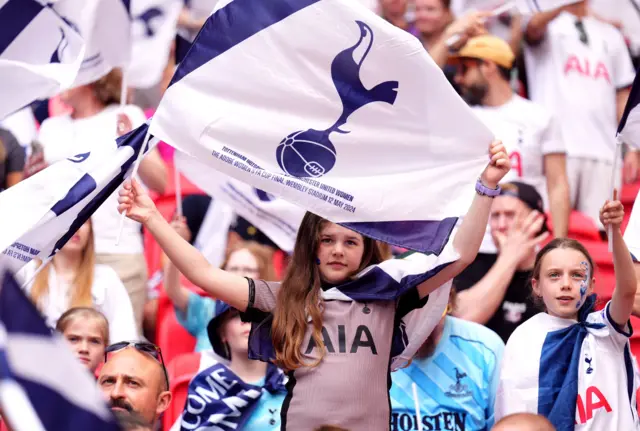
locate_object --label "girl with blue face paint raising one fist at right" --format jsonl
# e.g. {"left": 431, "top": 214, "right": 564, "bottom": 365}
{"left": 495, "top": 192, "right": 640, "bottom": 431}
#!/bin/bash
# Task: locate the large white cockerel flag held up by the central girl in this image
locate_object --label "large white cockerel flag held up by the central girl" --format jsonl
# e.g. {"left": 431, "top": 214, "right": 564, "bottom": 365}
{"left": 150, "top": 0, "right": 492, "bottom": 254}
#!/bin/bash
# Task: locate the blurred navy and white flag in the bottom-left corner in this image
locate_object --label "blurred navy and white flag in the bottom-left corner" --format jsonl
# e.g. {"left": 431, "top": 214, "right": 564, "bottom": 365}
{"left": 0, "top": 268, "right": 120, "bottom": 431}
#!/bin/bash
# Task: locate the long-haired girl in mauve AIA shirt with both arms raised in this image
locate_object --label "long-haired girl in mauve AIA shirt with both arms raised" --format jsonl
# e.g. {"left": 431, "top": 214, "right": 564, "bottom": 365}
{"left": 118, "top": 142, "right": 510, "bottom": 431}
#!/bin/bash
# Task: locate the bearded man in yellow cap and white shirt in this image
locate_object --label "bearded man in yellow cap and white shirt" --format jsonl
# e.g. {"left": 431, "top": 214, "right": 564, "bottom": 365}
{"left": 451, "top": 35, "right": 570, "bottom": 250}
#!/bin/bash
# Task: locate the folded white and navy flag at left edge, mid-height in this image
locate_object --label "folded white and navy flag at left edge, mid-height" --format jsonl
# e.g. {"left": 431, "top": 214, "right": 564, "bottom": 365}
{"left": 0, "top": 124, "right": 156, "bottom": 272}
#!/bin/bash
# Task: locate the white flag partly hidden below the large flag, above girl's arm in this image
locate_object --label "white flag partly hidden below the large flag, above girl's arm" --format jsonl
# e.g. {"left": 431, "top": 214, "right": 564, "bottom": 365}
{"left": 174, "top": 151, "right": 304, "bottom": 253}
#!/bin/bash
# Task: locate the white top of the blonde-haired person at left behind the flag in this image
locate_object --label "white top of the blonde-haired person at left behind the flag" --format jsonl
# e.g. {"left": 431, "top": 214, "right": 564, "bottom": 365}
{"left": 16, "top": 260, "right": 138, "bottom": 343}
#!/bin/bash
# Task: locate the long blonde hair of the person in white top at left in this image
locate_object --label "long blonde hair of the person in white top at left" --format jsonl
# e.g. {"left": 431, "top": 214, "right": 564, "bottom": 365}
{"left": 31, "top": 221, "right": 96, "bottom": 308}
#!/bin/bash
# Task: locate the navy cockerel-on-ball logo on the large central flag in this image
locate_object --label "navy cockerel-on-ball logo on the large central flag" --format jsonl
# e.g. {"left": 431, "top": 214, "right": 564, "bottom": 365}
{"left": 276, "top": 21, "right": 398, "bottom": 178}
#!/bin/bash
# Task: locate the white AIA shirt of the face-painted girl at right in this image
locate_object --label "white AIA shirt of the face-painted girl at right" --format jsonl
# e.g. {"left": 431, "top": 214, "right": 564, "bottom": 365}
{"left": 495, "top": 303, "right": 640, "bottom": 431}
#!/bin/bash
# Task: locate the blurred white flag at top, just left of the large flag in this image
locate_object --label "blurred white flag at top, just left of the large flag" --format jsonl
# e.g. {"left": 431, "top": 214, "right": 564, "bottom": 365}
{"left": 127, "top": 0, "right": 183, "bottom": 88}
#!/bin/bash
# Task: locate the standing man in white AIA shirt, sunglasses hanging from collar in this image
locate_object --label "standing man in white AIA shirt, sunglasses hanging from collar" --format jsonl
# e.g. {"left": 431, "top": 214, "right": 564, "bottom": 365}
{"left": 524, "top": 1, "right": 638, "bottom": 230}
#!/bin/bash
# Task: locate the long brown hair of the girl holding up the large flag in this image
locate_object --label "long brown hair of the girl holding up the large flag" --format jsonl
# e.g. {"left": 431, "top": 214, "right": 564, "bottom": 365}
{"left": 271, "top": 212, "right": 384, "bottom": 371}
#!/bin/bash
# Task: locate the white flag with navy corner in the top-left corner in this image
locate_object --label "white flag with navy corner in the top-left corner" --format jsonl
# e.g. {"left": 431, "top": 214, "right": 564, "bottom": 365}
{"left": 0, "top": 0, "right": 85, "bottom": 119}
